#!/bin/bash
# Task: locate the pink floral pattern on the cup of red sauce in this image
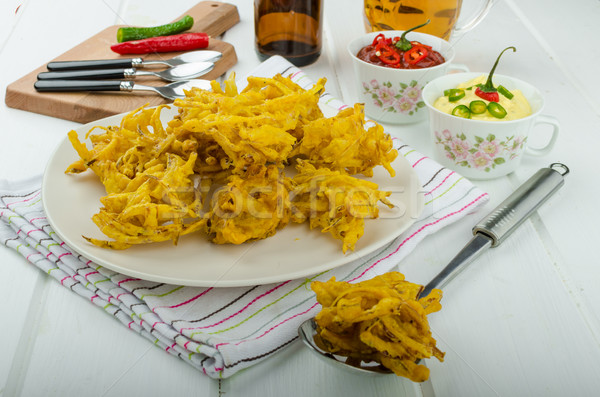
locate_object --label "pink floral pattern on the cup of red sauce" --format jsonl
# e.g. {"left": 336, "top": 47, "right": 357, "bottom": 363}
{"left": 363, "top": 79, "right": 425, "bottom": 116}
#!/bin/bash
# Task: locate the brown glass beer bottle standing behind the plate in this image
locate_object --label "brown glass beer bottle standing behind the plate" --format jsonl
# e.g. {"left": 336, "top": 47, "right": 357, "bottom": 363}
{"left": 254, "top": 0, "right": 323, "bottom": 66}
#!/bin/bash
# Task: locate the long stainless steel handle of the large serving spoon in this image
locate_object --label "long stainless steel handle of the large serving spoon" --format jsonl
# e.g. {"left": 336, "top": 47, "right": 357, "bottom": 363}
{"left": 419, "top": 163, "right": 569, "bottom": 296}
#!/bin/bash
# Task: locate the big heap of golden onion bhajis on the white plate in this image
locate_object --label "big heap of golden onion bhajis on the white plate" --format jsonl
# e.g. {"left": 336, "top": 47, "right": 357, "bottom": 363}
{"left": 66, "top": 74, "right": 398, "bottom": 252}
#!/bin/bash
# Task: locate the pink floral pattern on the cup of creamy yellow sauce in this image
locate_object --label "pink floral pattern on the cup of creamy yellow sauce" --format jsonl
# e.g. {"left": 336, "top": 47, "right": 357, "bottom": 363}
{"left": 435, "top": 129, "right": 527, "bottom": 172}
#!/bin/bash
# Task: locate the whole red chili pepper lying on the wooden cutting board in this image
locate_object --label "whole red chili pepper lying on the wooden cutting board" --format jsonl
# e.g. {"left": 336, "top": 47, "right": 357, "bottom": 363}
{"left": 110, "top": 33, "right": 208, "bottom": 55}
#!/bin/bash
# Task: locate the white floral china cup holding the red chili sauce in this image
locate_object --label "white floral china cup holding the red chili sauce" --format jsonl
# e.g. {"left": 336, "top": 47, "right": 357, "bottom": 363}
{"left": 348, "top": 30, "right": 469, "bottom": 124}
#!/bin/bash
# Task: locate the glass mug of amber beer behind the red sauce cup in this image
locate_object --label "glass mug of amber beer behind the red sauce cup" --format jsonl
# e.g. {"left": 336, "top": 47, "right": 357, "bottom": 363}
{"left": 364, "top": 0, "right": 494, "bottom": 40}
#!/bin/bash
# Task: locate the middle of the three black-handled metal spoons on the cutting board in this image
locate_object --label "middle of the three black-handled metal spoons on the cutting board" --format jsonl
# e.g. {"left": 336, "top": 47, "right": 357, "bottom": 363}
{"left": 37, "top": 62, "right": 215, "bottom": 81}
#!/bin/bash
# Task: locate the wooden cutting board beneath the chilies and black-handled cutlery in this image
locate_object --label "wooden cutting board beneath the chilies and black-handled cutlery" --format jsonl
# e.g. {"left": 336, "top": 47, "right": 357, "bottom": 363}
{"left": 5, "top": 1, "right": 240, "bottom": 123}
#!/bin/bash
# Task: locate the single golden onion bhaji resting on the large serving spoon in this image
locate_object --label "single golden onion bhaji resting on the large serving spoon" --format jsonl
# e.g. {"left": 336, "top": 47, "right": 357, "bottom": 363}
{"left": 311, "top": 272, "right": 444, "bottom": 382}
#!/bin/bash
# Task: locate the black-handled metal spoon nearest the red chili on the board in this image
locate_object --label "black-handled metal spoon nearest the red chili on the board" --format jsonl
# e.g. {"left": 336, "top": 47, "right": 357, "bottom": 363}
{"left": 46, "top": 50, "right": 223, "bottom": 71}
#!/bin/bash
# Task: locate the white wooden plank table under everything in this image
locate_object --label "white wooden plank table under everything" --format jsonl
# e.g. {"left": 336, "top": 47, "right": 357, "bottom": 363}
{"left": 0, "top": 0, "right": 600, "bottom": 396}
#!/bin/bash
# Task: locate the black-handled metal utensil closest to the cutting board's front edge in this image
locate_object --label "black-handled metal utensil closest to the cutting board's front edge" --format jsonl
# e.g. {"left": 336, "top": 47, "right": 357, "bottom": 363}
{"left": 34, "top": 80, "right": 211, "bottom": 99}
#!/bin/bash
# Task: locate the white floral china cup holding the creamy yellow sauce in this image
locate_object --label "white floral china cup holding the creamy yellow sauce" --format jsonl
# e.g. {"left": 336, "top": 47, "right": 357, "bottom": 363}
{"left": 423, "top": 73, "right": 559, "bottom": 179}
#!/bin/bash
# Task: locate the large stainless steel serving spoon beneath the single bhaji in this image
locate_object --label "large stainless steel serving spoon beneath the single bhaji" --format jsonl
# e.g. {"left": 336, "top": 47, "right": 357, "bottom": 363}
{"left": 298, "top": 163, "right": 569, "bottom": 374}
